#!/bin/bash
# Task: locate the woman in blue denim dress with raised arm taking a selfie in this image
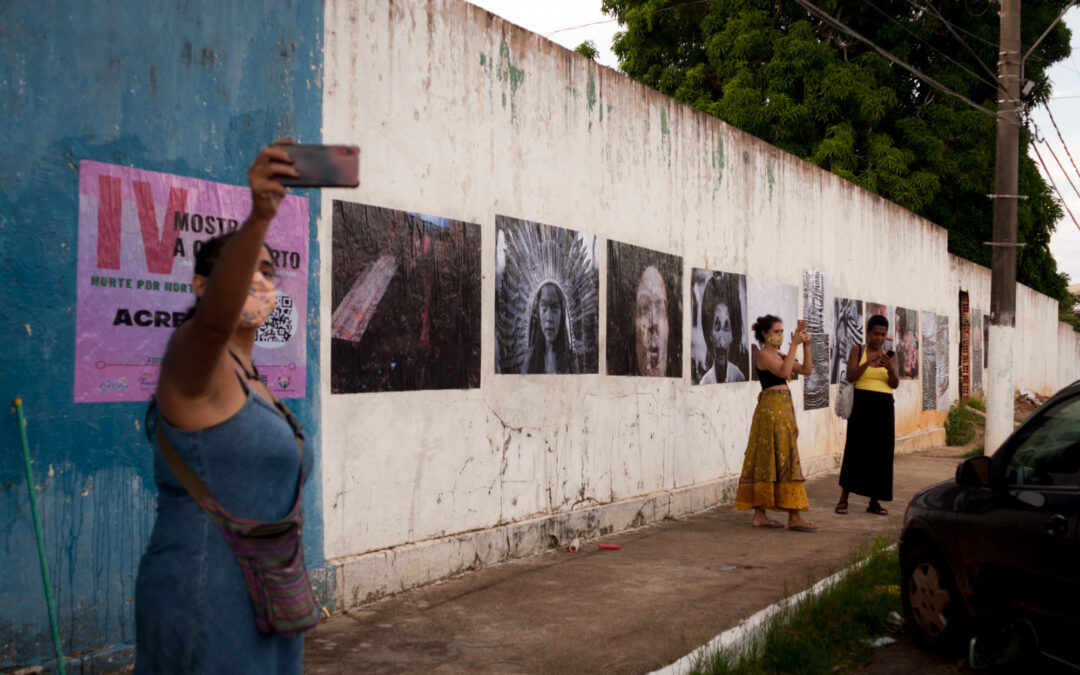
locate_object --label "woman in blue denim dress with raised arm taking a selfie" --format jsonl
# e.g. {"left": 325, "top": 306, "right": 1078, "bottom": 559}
{"left": 135, "top": 140, "right": 312, "bottom": 673}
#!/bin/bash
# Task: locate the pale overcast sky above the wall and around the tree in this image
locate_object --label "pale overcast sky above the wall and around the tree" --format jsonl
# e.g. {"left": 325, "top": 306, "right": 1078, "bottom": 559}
{"left": 470, "top": 0, "right": 1080, "bottom": 283}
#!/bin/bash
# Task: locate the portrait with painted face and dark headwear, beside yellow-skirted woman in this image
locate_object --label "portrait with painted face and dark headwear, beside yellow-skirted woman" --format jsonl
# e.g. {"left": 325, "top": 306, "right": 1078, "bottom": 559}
{"left": 690, "top": 268, "right": 750, "bottom": 384}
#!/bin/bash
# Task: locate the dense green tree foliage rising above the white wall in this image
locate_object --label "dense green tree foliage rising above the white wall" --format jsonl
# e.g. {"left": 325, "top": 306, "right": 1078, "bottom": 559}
{"left": 604, "top": 0, "right": 1070, "bottom": 300}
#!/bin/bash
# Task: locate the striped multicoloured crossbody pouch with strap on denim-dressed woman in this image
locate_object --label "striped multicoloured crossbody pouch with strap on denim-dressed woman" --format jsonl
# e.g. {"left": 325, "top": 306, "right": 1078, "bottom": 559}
{"left": 158, "top": 401, "right": 321, "bottom": 637}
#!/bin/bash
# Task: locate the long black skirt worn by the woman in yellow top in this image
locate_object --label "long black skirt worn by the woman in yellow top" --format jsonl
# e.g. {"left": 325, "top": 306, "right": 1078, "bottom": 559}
{"left": 840, "top": 389, "right": 896, "bottom": 501}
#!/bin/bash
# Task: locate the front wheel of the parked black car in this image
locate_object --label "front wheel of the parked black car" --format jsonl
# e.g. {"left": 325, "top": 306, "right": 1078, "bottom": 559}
{"left": 900, "top": 544, "right": 967, "bottom": 651}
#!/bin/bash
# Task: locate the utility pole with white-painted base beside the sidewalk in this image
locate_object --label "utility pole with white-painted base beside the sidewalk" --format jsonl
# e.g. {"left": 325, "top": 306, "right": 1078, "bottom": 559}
{"left": 989, "top": 0, "right": 1023, "bottom": 454}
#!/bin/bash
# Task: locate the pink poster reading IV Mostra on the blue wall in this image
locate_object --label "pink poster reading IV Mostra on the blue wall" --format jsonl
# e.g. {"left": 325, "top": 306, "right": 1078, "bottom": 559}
{"left": 75, "top": 160, "right": 309, "bottom": 403}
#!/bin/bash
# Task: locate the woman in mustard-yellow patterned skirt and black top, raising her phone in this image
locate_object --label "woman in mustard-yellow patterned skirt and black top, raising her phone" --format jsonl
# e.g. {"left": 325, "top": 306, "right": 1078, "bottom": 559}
{"left": 735, "top": 314, "right": 818, "bottom": 532}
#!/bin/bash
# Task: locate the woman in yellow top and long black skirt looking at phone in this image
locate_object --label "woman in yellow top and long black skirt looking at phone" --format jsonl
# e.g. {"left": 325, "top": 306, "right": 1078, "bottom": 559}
{"left": 836, "top": 314, "right": 900, "bottom": 515}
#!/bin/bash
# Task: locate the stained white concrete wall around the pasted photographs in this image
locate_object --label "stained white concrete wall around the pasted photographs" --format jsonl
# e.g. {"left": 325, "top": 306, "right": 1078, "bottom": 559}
{"left": 320, "top": 0, "right": 1075, "bottom": 604}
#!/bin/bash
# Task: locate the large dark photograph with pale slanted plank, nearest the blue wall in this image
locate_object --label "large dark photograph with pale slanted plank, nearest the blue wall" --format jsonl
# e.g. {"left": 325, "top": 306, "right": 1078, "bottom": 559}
{"left": 330, "top": 200, "right": 481, "bottom": 394}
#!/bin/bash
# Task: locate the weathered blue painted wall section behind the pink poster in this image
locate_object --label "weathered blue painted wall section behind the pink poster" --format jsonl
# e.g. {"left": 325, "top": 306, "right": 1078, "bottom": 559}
{"left": 0, "top": 0, "right": 324, "bottom": 670}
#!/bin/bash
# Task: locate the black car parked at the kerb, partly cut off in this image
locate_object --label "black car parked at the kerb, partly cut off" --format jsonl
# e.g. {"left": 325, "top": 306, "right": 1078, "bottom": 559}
{"left": 900, "top": 380, "right": 1080, "bottom": 664}
